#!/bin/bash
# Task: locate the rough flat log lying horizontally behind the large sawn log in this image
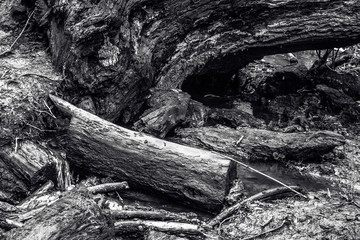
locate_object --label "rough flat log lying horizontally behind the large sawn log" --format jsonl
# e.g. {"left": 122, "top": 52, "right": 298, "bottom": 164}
{"left": 172, "top": 124, "right": 345, "bottom": 161}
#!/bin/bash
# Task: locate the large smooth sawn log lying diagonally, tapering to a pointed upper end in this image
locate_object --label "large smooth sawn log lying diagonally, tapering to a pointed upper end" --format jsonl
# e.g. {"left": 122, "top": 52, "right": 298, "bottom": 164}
{"left": 50, "top": 95, "right": 236, "bottom": 211}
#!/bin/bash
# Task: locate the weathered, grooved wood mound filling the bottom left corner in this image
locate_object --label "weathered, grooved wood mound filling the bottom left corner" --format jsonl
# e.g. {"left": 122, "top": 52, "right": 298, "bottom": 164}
{"left": 5, "top": 191, "right": 114, "bottom": 240}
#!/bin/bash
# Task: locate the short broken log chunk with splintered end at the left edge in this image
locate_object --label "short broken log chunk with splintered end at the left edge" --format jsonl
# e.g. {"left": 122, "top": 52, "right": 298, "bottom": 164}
{"left": 0, "top": 140, "right": 60, "bottom": 203}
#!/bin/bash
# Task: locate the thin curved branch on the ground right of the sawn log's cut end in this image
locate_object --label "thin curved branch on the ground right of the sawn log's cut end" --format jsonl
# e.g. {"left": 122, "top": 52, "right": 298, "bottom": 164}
{"left": 208, "top": 186, "right": 301, "bottom": 227}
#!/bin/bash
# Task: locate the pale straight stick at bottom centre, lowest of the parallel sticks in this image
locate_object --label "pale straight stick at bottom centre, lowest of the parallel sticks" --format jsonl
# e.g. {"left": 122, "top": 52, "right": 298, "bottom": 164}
{"left": 114, "top": 220, "right": 203, "bottom": 235}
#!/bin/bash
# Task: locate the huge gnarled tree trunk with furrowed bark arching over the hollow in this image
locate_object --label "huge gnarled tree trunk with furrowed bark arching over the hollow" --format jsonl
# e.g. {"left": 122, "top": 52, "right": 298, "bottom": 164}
{"left": 35, "top": 0, "right": 360, "bottom": 122}
